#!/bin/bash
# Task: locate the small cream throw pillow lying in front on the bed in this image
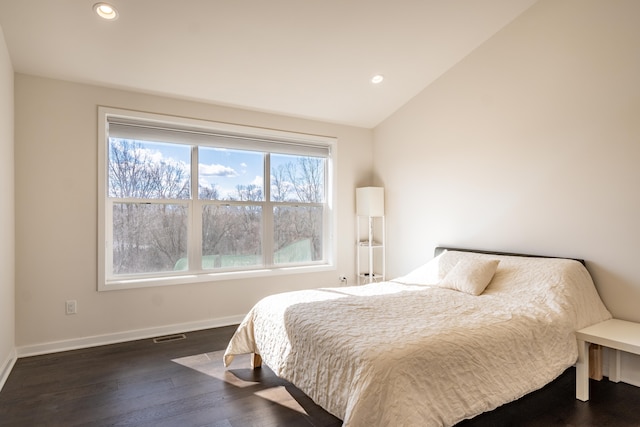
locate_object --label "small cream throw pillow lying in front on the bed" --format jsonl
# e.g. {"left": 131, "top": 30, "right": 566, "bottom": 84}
{"left": 438, "top": 258, "right": 500, "bottom": 295}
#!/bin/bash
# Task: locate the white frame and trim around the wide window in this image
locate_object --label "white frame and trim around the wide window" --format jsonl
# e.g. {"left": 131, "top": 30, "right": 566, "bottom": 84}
{"left": 98, "top": 106, "right": 337, "bottom": 291}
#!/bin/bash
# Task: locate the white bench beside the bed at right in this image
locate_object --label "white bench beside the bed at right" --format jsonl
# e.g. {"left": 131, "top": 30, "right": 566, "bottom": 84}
{"left": 576, "top": 319, "right": 640, "bottom": 401}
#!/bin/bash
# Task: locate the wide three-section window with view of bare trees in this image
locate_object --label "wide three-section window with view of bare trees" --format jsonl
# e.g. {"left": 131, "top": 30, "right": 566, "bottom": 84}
{"left": 98, "top": 108, "right": 335, "bottom": 290}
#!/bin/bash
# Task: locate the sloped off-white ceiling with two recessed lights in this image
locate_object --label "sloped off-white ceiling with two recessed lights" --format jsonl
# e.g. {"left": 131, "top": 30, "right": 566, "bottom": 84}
{"left": 0, "top": 0, "right": 536, "bottom": 128}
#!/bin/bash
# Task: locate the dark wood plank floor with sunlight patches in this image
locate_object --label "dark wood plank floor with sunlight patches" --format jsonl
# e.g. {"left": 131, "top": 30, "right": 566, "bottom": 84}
{"left": 0, "top": 327, "right": 640, "bottom": 427}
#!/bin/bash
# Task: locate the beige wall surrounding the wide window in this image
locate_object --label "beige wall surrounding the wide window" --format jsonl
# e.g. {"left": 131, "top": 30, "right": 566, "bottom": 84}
{"left": 15, "top": 74, "right": 372, "bottom": 354}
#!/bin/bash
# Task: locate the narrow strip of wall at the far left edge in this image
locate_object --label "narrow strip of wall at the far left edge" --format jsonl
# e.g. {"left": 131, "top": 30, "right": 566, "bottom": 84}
{"left": 0, "top": 28, "right": 15, "bottom": 389}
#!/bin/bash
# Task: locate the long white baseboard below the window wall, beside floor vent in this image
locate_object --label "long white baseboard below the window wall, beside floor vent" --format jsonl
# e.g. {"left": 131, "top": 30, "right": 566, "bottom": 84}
{"left": 15, "top": 315, "right": 244, "bottom": 360}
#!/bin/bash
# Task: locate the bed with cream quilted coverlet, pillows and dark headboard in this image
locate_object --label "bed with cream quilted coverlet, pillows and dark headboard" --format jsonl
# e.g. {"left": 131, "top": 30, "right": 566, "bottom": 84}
{"left": 224, "top": 248, "right": 611, "bottom": 427}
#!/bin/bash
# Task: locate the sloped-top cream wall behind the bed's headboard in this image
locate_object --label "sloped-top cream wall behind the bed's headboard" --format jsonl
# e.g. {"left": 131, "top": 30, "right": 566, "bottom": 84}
{"left": 374, "top": 0, "right": 640, "bottom": 383}
